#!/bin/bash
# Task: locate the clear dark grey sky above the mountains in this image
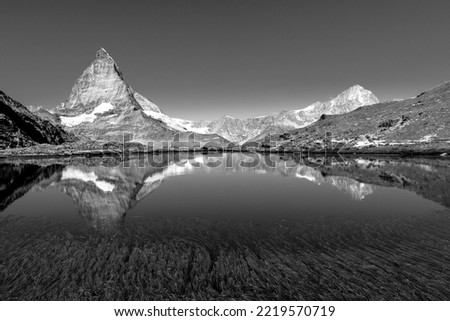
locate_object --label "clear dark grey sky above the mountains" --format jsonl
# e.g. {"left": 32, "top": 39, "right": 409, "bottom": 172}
{"left": 0, "top": 0, "right": 450, "bottom": 120}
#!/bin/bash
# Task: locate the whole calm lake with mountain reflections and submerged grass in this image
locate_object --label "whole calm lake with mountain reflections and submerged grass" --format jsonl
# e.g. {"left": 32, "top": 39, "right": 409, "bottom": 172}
{"left": 0, "top": 153, "right": 450, "bottom": 300}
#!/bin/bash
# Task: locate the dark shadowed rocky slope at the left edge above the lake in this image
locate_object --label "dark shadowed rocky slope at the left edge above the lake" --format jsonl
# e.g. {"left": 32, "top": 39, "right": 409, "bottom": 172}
{"left": 0, "top": 91, "right": 76, "bottom": 149}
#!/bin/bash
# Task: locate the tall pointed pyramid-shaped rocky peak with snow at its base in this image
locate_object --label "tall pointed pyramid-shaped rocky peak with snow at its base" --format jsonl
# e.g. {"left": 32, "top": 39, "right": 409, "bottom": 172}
{"left": 56, "top": 48, "right": 162, "bottom": 134}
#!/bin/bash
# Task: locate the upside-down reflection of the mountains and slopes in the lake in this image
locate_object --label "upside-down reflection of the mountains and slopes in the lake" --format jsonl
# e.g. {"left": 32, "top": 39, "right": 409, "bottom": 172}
{"left": 0, "top": 153, "right": 450, "bottom": 232}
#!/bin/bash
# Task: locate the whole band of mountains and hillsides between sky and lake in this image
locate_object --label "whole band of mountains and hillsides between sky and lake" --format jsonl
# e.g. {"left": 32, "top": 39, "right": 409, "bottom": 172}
{"left": 0, "top": 48, "right": 450, "bottom": 152}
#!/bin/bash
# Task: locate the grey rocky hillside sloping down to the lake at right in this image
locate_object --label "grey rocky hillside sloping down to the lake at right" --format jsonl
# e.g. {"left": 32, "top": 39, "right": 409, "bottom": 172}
{"left": 266, "top": 82, "right": 450, "bottom": 152}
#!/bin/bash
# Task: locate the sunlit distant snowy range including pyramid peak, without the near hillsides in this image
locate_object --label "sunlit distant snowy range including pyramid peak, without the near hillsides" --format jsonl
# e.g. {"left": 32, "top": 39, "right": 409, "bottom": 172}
{"left": 16, "top": 48, "right": 378, "bottom": 143}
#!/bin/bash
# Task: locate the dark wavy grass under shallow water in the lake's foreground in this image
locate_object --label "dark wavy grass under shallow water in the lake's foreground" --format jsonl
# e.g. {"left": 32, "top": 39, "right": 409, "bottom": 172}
{"left": 0, "top": 213, "right": 450, "bottom": 300}
